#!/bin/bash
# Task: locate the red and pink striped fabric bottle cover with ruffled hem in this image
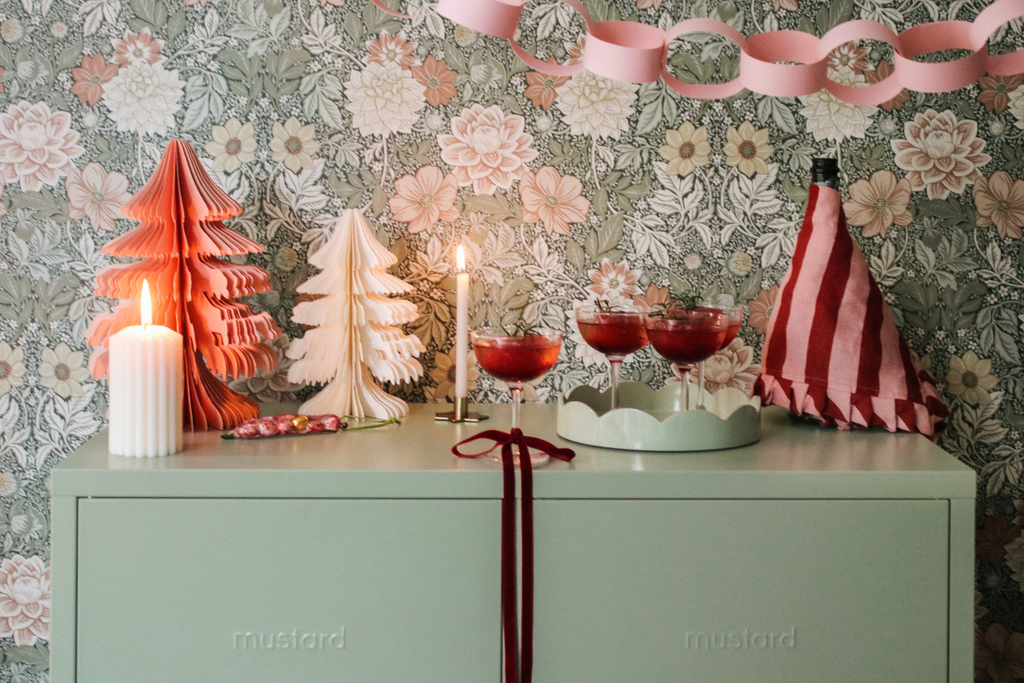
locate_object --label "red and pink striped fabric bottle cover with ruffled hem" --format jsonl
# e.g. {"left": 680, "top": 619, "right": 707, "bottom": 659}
{"left": 754, "top": 185, "right": 949, "bottom": 436}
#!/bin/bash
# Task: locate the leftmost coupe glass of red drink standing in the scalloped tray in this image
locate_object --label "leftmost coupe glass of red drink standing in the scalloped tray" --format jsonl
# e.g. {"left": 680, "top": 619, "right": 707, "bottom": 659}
{"left": 577, "top": 305, "right": 647, "bottom": 411}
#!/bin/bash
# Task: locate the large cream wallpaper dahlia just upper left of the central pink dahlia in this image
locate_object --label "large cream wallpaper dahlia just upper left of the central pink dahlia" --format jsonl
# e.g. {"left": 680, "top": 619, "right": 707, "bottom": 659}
{"left": 345, "top": 61, "right": 427, "bottom": 136}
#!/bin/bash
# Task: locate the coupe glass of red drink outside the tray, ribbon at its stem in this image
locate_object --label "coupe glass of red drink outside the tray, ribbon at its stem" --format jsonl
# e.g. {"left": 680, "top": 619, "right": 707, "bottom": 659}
{"left": 469, "top": 328, "right": 562, "bottom": 440}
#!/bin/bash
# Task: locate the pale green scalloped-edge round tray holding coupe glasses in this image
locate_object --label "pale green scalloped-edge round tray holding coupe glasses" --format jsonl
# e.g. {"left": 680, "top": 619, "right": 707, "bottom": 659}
{"left": 558, "top": 382, "right": 761, "bottom": 453}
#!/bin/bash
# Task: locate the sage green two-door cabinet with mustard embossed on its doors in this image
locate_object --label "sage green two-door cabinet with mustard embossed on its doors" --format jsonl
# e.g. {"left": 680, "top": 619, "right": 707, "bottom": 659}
{"left": 50, "top": 404, "right": 975, "bottom": 683}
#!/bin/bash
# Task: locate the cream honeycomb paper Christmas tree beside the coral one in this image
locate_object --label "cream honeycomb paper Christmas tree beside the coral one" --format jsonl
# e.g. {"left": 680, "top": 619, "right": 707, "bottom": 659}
{"left": 288, "top": 209, "right": 426, "bottom": 418}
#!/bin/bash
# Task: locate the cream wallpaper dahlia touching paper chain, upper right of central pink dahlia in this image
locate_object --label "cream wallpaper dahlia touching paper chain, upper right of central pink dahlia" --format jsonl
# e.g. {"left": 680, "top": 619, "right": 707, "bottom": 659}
{"left": 555, "top": 71, "right": 639, "bottom": 139}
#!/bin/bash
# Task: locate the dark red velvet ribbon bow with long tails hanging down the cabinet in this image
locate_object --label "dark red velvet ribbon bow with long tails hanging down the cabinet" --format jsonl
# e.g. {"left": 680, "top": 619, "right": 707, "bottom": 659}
{"left": 452, "top": 429, "right": 575, "bottom": 683}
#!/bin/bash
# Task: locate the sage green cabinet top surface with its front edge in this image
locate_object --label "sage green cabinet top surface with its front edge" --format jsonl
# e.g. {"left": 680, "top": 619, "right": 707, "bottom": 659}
{"left": 51, "top": 403, "right": 976, "bottom": 499}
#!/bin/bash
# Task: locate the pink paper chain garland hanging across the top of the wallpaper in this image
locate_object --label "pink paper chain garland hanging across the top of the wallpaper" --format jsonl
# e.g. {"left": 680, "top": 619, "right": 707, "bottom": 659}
{"left": 372, "top": 0, "right": 1024, "bottom": 104}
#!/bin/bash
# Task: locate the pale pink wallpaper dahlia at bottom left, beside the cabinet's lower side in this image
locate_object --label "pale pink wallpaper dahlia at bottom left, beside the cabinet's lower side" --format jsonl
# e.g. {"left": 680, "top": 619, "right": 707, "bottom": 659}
{"left": 0, "top": 555, "right": 50, "bottom": 647}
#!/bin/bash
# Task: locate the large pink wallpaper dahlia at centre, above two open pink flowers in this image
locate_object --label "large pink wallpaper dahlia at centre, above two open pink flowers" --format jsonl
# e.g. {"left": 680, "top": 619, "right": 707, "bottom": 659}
{"left": 437, "top": 104, "right": 537, "bottom": 195}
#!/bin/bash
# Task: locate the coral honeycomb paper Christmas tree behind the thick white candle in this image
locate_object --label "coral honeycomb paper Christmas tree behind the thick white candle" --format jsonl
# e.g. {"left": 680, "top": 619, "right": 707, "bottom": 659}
{"left": 86, "top": 140, "right": 281, "bottom": 430}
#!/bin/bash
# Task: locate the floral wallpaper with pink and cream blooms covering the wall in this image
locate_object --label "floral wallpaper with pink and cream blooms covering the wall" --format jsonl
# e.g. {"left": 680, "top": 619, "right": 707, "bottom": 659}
{"left": 0, "top": 0, "right": 1024, "bottom": 683}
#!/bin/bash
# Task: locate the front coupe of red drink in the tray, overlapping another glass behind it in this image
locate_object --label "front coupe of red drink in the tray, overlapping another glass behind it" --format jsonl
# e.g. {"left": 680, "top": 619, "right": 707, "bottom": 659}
{"left": 647, "top": 306, "right": 729, "bottom": 411}
